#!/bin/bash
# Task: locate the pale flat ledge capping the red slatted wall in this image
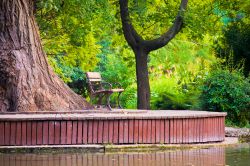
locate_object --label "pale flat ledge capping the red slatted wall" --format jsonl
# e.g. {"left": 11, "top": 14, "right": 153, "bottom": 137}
{"left": 0, "top": 109, "right": 227, "bottom": 121}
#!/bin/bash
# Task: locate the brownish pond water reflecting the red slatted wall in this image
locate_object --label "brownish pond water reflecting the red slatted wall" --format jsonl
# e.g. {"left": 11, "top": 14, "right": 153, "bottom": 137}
{"left": 0, "top": 144, "right": 250, "bottom": 166}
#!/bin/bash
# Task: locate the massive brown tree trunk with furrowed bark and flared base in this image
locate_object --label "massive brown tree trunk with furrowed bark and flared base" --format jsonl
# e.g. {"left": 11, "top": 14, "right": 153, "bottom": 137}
{"left": 0, "top": 0, "right": 91, "bottom": 112}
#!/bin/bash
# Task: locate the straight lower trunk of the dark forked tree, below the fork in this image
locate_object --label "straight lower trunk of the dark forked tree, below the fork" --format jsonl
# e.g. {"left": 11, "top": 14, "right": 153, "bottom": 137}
{"left": 134, "top": 49, "right": 150, "bottom": 110}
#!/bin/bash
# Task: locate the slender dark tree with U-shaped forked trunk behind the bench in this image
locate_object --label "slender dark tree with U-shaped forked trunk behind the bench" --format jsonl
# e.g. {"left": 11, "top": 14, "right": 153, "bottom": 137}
{"left": 119, "top": 0, "right": 188, "bottom": 109}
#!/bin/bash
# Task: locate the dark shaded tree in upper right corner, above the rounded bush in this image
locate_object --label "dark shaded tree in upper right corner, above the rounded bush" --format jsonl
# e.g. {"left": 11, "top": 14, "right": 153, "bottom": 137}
{"left": 217, "top": 0, "right": 250, "bottom": 77}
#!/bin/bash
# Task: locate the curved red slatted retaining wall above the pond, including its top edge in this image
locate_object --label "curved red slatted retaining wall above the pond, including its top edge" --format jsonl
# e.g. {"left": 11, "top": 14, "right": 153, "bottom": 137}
{"left": 0, "top": 111, "right": 225, "bottom": 146}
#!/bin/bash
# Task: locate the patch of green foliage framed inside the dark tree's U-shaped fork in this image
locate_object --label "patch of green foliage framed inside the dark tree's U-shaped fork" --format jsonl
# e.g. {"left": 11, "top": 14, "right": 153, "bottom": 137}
{"left": 129, "top": 0, "right": 179, "bottom": 39}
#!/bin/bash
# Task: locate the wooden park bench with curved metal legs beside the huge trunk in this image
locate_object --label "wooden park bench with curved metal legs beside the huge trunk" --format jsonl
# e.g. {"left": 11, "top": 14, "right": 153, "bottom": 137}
{"left": 86, "top": 72, "right": 124, "bottom": 110}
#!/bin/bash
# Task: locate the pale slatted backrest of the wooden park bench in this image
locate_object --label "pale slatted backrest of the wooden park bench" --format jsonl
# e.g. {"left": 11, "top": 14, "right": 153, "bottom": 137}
{"left": 86, "top": 72, "right": 103, "bottom": 94}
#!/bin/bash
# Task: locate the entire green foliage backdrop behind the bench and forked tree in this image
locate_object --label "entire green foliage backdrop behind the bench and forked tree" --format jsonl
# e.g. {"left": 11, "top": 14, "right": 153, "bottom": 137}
{"left": 36, "top": 0, "right": 250, "bottom": 128}
